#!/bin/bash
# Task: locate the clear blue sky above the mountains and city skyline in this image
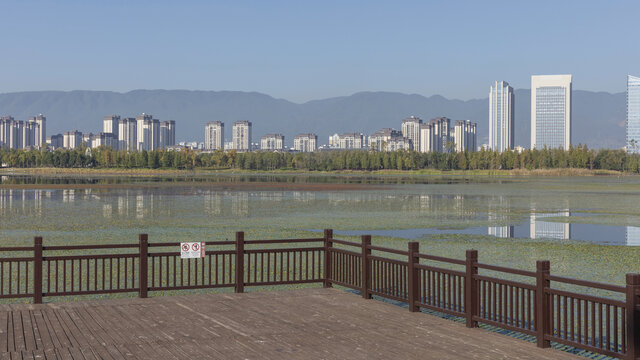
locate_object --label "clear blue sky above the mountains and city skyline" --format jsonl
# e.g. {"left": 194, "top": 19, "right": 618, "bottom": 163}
{"left": 0, "top": 0, "right": 640, "bottom": 102}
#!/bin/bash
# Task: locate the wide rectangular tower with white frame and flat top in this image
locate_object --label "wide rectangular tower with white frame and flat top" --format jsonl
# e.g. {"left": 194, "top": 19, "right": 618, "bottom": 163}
{"left": 531, "top": 75, "right": 572, "bottom": 150}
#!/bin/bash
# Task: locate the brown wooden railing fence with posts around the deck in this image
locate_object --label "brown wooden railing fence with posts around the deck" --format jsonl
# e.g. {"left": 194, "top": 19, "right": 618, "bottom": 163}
{"left": 0, "top": 230, "right": 640, "bottom": 360}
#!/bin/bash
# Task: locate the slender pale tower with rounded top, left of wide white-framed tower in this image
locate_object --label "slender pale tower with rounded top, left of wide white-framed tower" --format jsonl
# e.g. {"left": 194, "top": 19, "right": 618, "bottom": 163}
{"left": 489, "top": 81, "right": 515, "bottom": 152}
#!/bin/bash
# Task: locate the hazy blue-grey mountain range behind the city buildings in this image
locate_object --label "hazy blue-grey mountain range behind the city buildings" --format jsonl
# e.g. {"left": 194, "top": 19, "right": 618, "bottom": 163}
{"left": 0, "top": 89, "right": 626, "bottom": 148}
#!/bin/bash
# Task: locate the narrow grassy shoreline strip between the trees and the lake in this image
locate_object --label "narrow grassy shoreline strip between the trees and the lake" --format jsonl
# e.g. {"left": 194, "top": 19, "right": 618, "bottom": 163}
{"left": 0, "top": 168, "right": 637, "bottom": 177}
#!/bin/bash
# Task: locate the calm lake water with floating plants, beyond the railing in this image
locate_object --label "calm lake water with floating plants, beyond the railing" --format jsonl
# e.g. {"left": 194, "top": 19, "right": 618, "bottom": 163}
{"left": 0, "top": 175, "right": 640, "bottom": 246}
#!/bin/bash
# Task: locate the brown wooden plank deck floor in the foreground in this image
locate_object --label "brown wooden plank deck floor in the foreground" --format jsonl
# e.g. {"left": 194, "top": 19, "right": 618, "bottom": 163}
{"left": 0, "top": 288, "right": 578, "bottom": 359}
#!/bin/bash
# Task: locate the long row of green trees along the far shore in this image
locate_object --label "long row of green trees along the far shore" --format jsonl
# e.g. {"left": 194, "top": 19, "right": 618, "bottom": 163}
{"left": 0, "top": 145, "right": 640, "bottom": 173}
